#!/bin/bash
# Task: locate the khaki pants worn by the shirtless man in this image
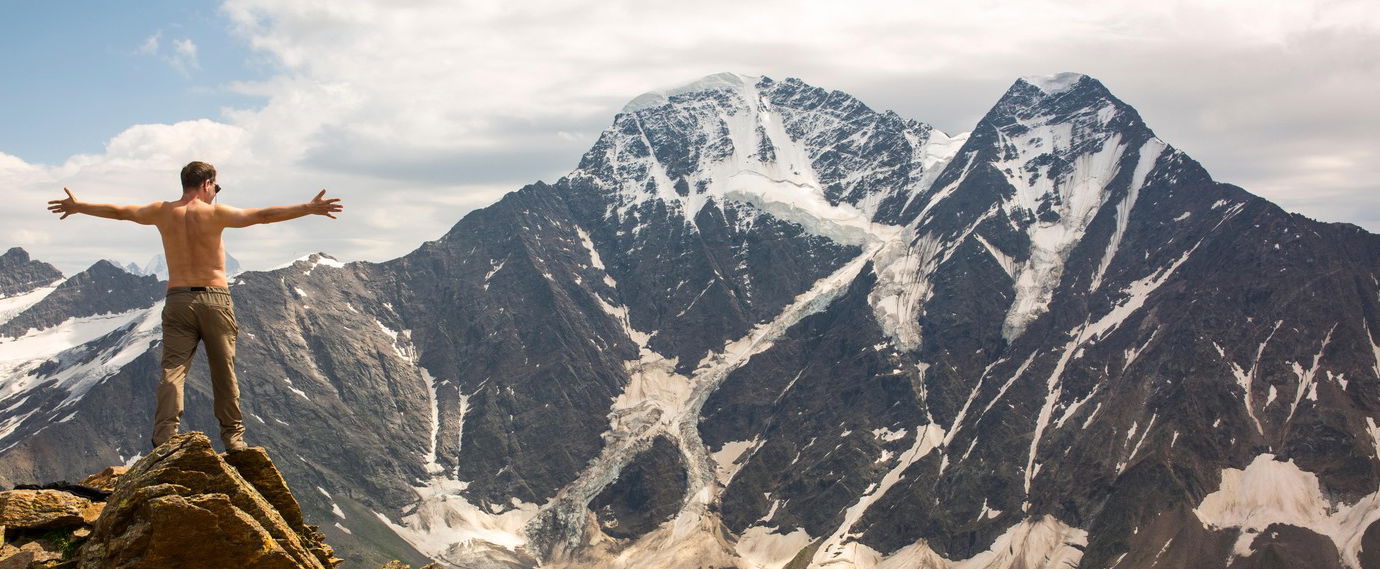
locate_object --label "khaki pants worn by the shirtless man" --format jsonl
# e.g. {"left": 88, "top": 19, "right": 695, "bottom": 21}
{"left": 153, "top": 286, "right": 244, "bottom": 450}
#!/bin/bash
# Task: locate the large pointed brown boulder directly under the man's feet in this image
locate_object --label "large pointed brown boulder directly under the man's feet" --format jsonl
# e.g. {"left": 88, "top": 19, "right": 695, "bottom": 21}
{"left": 79, "top": 432, "right": 339, "bottom": 569}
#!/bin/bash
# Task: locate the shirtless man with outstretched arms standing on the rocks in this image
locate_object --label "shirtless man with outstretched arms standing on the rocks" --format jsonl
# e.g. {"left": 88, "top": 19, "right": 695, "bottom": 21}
{"left": 48, "top": 162, "right": 344, "bottom": 452}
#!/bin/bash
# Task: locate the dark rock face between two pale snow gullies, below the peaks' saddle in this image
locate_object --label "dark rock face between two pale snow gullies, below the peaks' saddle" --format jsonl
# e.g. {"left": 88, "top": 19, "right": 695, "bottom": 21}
{"left": 700, "top": 271, "right": 925, "bottom": 536}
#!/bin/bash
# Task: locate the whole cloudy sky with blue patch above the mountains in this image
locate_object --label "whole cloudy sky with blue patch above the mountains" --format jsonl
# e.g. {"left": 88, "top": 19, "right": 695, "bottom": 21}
{"left": 0, "top": 0, "right": 1380, "bottom": 275}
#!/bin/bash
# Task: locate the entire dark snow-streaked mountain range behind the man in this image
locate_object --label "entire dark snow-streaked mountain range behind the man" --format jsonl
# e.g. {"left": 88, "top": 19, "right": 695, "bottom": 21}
{"left": 0, "top": 75, "right": 1380, "bottom": 568}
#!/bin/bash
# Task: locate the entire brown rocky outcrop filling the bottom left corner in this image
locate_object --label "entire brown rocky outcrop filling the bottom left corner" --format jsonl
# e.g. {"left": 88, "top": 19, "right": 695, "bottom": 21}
{"left": 0, "top": 432, "right": 439, "bottom": 569}
